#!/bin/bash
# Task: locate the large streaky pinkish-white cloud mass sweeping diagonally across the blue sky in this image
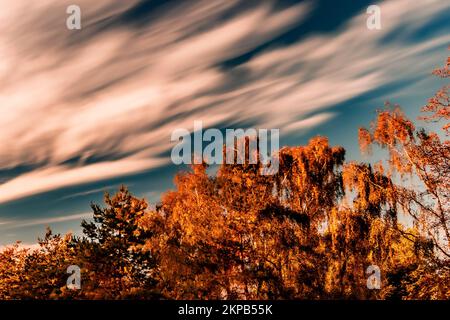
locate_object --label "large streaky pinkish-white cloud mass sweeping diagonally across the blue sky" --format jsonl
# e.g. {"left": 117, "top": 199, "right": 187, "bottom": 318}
{"left": 0, "top": 0, "right": 450, "bottom": 203}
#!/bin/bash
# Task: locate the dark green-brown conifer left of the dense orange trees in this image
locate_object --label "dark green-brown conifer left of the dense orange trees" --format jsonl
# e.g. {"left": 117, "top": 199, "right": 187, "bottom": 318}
{"left": 74, "top": 186, "right": 162, "bottom": 299}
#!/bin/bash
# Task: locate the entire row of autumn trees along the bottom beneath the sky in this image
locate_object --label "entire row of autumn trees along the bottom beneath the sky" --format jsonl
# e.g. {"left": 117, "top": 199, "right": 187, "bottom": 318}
{"left": 0, "top": 52, "right": 450, "bottom": 299}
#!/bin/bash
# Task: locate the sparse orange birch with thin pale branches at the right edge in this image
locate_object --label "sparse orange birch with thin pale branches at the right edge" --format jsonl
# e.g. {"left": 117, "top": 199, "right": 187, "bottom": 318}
{"left": 359, "top": 51, "right": 450, "bottom": 299}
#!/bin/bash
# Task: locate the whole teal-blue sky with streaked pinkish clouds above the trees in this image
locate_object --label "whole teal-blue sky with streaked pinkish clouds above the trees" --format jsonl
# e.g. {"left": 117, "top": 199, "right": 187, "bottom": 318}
{"left": 0, "top": 0, "right": 450, "bottom": 245}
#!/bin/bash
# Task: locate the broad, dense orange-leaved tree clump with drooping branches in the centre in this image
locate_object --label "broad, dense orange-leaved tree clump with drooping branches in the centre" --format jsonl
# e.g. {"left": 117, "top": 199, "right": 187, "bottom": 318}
{"left": 140, "top": 137, "right": 414, "bottom": 299}
